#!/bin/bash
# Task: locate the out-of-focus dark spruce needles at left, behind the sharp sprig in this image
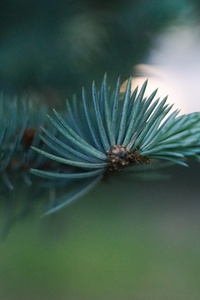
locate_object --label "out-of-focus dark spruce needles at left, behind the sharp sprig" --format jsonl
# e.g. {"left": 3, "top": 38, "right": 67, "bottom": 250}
{"left": 0, "top": 95, "right": 52, "bottom": 235}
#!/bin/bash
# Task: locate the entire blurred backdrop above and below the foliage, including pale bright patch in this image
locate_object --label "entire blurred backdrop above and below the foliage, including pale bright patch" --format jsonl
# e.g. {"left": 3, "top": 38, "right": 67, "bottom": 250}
{"left": 0, "top": 0, "right": 200, "bottom": 300}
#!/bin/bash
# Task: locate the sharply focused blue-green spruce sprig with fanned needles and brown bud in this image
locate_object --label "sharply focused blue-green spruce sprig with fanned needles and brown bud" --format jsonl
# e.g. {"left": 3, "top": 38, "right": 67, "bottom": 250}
{"left": 30, "top": 75, "right": 200, "bottom": 214}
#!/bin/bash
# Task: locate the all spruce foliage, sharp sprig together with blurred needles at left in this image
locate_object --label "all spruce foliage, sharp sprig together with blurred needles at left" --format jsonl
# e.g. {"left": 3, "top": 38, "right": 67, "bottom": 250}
{"left": 0, "top": 75, "right": 200, "bottom": 233}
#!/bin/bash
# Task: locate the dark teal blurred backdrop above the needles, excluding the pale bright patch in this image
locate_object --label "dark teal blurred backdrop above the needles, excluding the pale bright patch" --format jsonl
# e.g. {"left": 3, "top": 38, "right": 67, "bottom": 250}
{"left": 0, "top": 0, "right": 200, "bottom": 97}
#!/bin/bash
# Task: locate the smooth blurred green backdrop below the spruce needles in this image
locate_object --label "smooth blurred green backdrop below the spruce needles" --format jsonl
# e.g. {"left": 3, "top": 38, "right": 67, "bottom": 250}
{"left": 0, "top": 163, "right": 200, "bottom": 300}
